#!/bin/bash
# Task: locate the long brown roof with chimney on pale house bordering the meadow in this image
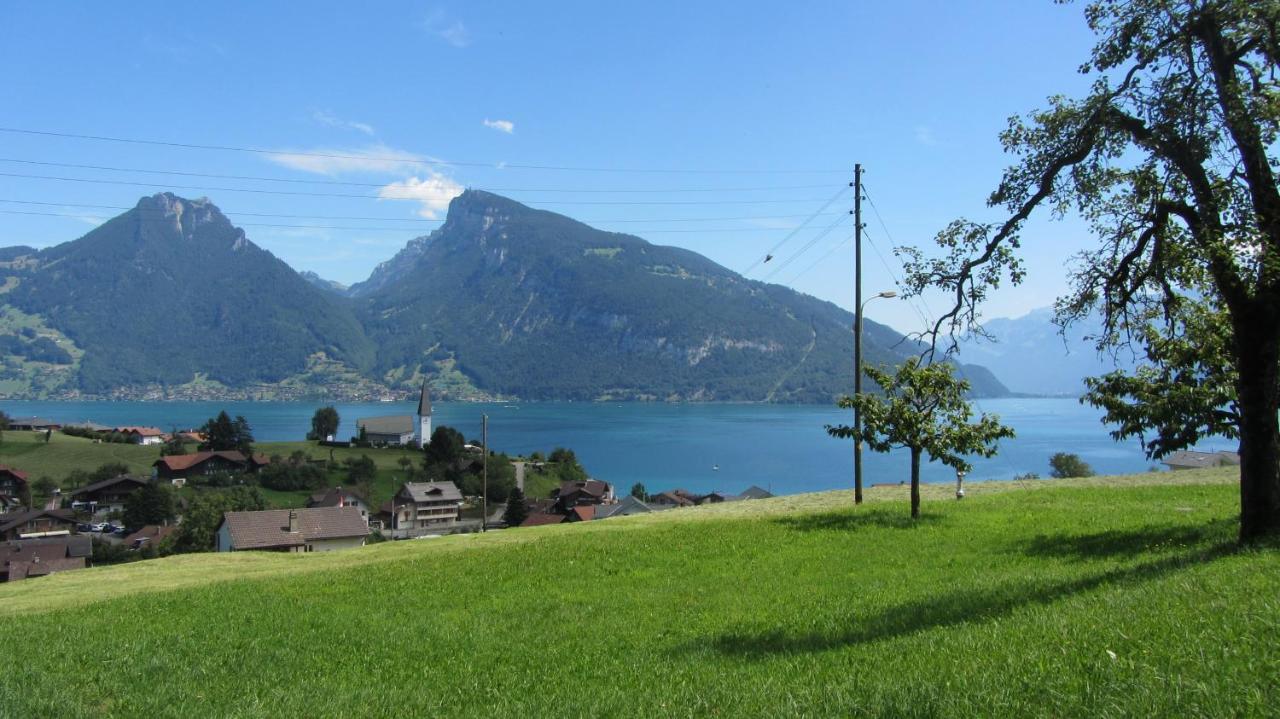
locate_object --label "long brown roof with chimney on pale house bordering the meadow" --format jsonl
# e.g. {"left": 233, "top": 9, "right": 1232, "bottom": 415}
{"left": 223, "top": 507, "right": 369, "bottom": 549}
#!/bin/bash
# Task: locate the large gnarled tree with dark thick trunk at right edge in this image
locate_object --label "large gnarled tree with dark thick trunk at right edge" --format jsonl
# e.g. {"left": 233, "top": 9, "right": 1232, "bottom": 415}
{"left": 904, "top": 0, "right": 1280, "bottom": 540}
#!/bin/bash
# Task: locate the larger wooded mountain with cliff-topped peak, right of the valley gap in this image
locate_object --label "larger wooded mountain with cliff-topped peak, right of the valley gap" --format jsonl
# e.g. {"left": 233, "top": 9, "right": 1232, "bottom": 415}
{"left": 352, "top": 191, "right": 1006, "bottom": 402}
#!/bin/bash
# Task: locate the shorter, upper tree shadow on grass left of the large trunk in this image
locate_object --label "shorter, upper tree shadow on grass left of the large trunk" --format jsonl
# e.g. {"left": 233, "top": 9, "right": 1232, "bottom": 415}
{"left": 1018, "top": 518, "right": 1238, "bottom": 560}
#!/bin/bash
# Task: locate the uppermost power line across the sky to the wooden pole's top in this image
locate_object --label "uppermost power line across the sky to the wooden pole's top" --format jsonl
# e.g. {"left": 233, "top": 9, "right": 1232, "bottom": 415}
{"left": 0, "top": 127, "right": 847, "bottom": 175}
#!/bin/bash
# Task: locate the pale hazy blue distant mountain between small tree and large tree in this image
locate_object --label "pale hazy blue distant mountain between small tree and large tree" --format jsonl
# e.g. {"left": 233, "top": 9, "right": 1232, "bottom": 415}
{"left": 959, "top": 307, "right": 1134, "bottom": 395}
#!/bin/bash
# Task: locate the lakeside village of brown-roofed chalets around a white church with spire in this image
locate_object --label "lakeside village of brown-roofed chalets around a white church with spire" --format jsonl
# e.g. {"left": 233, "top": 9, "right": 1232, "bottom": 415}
{"left": 0, "top": 384, "right": 772, "bottom": 581}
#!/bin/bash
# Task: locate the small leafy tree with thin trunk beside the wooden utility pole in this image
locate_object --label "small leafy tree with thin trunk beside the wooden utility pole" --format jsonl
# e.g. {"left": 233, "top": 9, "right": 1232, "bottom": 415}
{"left": 827, "top": 357, "right": 1014, "bottom": 518}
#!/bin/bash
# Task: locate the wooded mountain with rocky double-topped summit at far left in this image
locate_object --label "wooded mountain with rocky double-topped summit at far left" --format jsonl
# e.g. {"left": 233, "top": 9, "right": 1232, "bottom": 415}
{"left": 0, "top": 193, "right": 374, "bottom": 393}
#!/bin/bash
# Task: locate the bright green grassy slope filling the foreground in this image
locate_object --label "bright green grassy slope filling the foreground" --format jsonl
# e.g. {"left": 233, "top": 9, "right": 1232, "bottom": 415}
{"left": 0, "top": 471, "right": 1280, "bottom": 716}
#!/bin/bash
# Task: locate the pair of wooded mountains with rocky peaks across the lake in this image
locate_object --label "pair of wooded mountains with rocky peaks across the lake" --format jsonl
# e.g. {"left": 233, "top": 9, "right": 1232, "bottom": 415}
{"left": 0, "top": 191, "right": 1007, "bottom": 402}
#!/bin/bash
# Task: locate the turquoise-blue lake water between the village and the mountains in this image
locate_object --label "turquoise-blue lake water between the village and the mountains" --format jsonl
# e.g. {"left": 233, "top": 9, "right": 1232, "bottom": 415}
{"left": 0, "top": 399, "right": 1234, "bottom": 494}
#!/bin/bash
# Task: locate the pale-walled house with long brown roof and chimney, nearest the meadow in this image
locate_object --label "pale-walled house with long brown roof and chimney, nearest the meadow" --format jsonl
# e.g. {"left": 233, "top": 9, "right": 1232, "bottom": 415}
{"left": 216, "top": 507, "right": 369, "bottom": 551}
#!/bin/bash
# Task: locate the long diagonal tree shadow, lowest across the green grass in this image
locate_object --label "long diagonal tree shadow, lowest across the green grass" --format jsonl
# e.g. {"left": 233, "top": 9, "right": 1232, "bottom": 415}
{"left": 686, "top": 542, "right": 1236, "bottom": 659}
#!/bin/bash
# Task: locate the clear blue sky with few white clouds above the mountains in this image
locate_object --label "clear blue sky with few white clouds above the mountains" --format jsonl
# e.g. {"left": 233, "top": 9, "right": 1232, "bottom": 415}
{"left": 0, "top": 0, "right": 1092, "bottom": 331}
